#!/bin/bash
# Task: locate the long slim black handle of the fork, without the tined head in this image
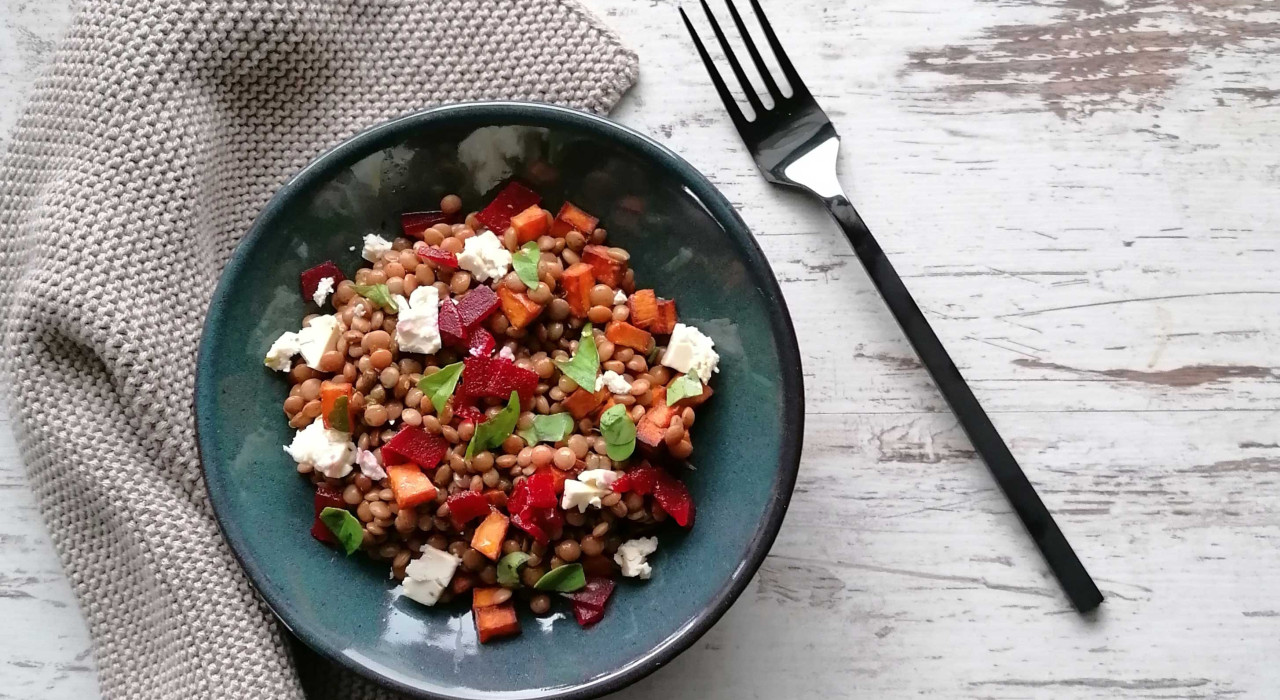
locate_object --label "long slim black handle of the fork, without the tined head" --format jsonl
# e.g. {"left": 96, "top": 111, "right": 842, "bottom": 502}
{"left": 823, "top": 195, "right": 1102, "bottom": 613}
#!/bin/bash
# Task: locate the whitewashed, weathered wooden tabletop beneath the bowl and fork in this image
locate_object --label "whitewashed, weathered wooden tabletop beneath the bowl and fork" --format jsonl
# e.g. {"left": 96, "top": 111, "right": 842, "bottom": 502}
{"left": 0, "top": 0, "right": 1280, "bottom": 699}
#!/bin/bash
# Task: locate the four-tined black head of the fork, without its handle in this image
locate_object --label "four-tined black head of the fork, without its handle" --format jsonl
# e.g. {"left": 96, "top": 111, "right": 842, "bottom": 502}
{"left": 680, "top": 0, "right": 840, "bottom": 197}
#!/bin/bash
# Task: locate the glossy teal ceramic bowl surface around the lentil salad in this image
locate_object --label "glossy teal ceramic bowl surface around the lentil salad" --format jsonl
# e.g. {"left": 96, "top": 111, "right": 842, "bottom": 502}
{"left": 196, "top": 102, "right": 804, "bottom": 700}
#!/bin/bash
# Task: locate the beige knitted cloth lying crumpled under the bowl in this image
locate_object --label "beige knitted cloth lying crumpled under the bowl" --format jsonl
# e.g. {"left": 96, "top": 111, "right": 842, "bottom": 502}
{"left": 0, "top": 0, "right": 637, "bottom": 700}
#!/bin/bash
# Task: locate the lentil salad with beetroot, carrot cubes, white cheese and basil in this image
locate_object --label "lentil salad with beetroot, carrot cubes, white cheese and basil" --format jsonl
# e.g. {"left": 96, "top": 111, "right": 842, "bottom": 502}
{"left": 265, "top": 182, "right": 718, "bottom": 642}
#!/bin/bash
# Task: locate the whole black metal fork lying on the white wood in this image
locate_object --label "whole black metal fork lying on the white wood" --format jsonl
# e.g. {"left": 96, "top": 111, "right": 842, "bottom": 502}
{"left": 680, "top": 0, "right": 1102, "bottom": 613}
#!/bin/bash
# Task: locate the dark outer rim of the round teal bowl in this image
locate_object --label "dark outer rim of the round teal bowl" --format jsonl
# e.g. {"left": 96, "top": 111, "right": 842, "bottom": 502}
{"left": 192, "top": 101, "right": 805, "bottom": 700}
